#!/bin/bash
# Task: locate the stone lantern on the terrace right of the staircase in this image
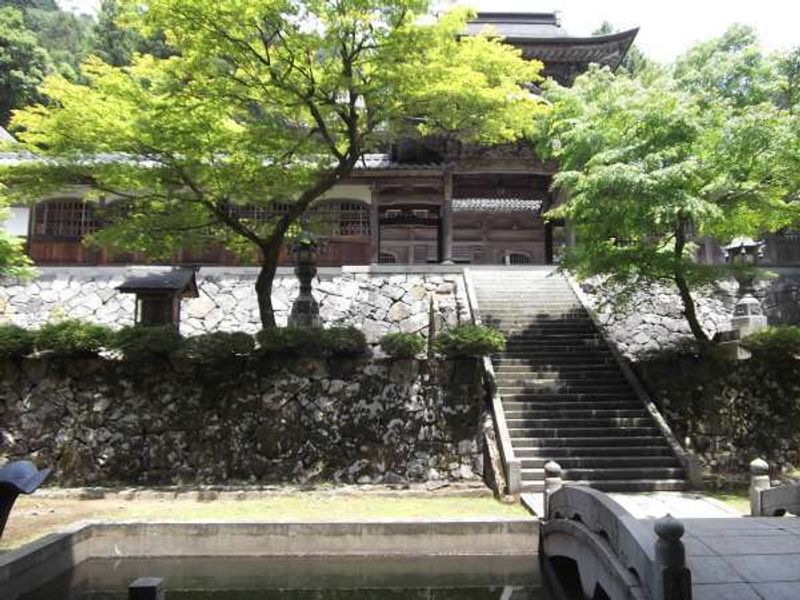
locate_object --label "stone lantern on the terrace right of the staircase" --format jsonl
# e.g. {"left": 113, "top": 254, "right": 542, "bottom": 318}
{"left": 722, "top": 237, "right": 767, "bottom": 338}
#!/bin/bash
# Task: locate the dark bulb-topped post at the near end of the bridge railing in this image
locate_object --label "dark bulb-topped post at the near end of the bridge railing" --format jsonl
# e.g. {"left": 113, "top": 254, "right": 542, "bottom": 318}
{"left": 653, "top": 514, "right": 692, "bottom": 600}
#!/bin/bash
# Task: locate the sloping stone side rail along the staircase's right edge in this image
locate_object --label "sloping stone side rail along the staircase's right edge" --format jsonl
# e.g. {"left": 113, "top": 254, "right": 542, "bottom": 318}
{"left": 564, "top": 273, "right": 704, "bottom": 490}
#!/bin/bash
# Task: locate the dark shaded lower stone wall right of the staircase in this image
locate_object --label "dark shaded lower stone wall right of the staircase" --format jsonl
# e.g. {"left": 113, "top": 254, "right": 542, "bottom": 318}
{"left": 635, "top": 355, "right": 800, "bottom": 482}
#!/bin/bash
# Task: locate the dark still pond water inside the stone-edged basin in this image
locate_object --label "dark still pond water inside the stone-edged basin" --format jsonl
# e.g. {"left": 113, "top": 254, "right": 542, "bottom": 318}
{"left": 20, "top": 556, "right": 549, "bottom": 600}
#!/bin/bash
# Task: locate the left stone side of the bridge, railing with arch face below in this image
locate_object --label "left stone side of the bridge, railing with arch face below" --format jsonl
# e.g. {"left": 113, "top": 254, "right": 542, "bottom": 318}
{"left": 541, "top": 462, "right": 692, "bottom": 600}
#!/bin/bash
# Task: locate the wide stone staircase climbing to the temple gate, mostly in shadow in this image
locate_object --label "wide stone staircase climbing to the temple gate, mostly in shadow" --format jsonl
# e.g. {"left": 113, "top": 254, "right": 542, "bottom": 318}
{"left": 471, "top": 268, "right": 688, "bottom": 492}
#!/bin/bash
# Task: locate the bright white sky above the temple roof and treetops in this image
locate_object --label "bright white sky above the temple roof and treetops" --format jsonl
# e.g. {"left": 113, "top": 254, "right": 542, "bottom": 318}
{"left": 59, "top": 0, "right": 800, "bottom": 62}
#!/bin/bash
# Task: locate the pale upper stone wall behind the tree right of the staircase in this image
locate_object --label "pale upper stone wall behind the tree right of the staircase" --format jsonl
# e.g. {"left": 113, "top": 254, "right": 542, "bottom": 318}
{"left": 581, "top": 269, "right": 800, "bottom": 361}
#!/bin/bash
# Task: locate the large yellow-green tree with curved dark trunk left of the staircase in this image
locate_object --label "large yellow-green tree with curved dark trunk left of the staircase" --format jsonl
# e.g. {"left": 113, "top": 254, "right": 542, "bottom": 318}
{"left": 3, "top": 0, "right": 543, "bottom": 327}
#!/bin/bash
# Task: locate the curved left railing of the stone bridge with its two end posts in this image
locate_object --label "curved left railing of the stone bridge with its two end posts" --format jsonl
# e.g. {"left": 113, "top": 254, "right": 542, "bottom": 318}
{"left": 543, "top": 462, "right": 692, "bottom": 600}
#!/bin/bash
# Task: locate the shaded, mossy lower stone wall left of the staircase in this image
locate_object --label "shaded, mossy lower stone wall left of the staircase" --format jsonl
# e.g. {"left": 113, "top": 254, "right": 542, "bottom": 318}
{"left": 0, "top": 358, "right": 483, "bottom": 485}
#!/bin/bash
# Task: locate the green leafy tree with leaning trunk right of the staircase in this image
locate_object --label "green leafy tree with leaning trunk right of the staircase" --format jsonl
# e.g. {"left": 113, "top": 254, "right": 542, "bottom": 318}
{"left": 540, "top": 30, "right": 800, "bottom": 347}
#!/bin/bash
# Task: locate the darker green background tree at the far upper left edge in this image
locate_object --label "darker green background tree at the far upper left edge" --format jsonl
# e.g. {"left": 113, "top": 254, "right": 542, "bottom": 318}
{"left": 0, "top": 7, "right": 50, "bottom": 125}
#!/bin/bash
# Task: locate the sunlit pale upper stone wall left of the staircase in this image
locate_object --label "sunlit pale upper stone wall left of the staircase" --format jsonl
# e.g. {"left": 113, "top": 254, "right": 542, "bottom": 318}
{"left": 0, "top": 267, "right": 469, "bottom": 344}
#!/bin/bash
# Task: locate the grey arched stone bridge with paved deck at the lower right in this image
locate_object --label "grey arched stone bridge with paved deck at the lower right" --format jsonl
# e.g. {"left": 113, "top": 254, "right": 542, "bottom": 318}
{"left": 540, "top": 462, "right": 800, "bottom": 600}
